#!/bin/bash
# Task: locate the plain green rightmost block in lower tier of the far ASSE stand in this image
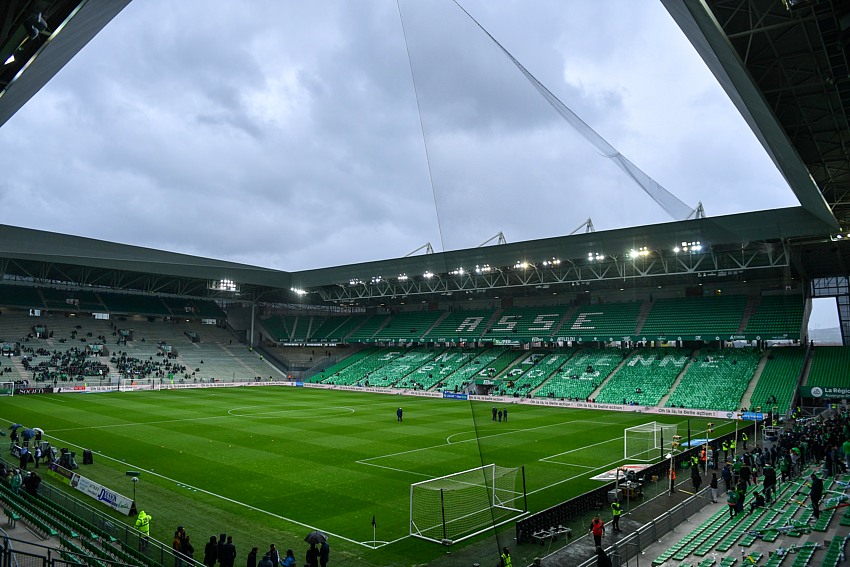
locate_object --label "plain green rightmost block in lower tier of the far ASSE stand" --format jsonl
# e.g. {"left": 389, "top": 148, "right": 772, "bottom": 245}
{"left": 750, "top": 347, "right": 806, "bottom": 413}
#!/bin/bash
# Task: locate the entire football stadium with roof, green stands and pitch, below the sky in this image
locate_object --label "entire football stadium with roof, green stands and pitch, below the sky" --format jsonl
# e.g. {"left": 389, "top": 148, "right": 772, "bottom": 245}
{"left": 0, "top": 0, "right": 850, "bottom": 567}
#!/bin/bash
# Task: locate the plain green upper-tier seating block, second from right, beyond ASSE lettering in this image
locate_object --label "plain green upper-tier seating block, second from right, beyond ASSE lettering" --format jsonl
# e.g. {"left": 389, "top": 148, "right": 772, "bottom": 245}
{"left": 640, "top": 295, "right": 747, "bottom": 338}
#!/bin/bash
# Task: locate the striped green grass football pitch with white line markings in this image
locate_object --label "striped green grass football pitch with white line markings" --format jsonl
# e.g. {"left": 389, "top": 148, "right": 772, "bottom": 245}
{"left": 0, "top": 387, "right": 734, "bottom": 565}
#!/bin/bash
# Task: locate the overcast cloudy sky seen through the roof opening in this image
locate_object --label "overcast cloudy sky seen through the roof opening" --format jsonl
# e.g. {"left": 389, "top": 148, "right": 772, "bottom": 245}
{"left": 0, "top": 0, "right": 798, "bottom": 270}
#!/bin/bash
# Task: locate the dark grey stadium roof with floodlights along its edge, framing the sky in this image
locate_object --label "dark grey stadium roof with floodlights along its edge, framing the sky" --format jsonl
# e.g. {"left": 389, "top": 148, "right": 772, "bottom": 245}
{"left": 0, "top": 0, "right": 850, "bottom": 310}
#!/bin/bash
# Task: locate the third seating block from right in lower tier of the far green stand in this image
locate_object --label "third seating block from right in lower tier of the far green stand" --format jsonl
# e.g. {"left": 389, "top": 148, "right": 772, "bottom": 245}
{"left": 596, "top": 348, "right": 691, "bottom": 406}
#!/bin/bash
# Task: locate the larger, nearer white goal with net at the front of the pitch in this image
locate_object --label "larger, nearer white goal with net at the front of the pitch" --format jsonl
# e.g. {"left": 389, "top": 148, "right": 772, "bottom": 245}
{"left": 410, "top": 464, "right": 528, "bottom": 544}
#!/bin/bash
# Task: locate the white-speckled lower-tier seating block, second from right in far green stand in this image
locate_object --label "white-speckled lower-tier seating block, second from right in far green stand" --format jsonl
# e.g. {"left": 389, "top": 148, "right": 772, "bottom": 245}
{"left": 666, "top": 349, "right": 761, "bottom": 411}
